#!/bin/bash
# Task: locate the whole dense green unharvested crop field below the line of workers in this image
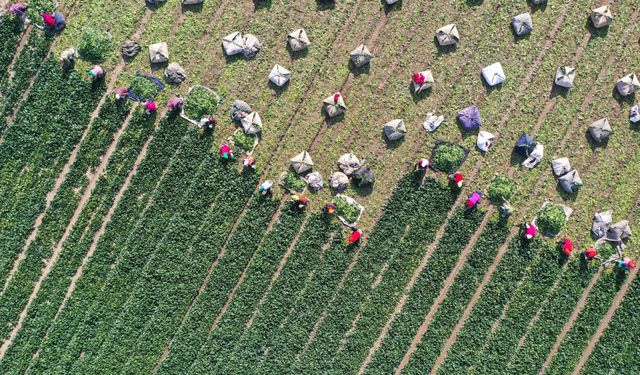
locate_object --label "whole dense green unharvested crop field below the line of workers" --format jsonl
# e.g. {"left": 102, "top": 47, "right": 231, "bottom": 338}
{"left": 0, "top": 1, "right": 640, "bottom": 374}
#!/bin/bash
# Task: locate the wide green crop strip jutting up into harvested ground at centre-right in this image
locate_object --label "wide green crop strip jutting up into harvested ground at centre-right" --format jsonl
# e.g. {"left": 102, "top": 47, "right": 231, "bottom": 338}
{"left": 292, "top": 178, "right": 458, "bottom": 374}
